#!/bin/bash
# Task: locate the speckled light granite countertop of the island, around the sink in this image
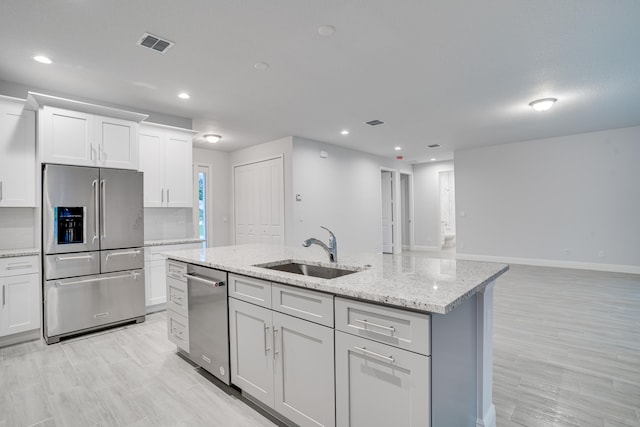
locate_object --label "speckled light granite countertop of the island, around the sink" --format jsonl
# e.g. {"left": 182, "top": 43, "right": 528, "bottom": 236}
{"left": 164, "top": 244, "right": 509, "bottom": 314}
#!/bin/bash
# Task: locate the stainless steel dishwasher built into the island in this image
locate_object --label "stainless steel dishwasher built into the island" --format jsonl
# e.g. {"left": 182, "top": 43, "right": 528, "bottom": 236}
{"left": 186, "top": 264, "right": 230, "bottom": 384}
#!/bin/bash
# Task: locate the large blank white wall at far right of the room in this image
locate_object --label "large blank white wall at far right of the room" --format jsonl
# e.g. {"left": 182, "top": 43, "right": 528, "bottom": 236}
{"left": 455, "top": 127, "right": 640, "bottom": 272}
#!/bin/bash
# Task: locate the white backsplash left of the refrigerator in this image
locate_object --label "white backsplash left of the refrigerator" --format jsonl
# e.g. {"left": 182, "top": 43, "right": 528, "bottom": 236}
{"left": 0, "top": 208, "right": 40, "bottom": 250}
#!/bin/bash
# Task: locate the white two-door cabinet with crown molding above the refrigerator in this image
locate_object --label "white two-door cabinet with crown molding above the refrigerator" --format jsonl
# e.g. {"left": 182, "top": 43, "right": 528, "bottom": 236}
{"left": 28, "top": 93, "right": 147, "bottom": 170}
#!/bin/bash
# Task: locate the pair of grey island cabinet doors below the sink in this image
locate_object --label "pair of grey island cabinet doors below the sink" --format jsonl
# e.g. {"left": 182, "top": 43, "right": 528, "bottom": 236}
{"left": 229, "top": 298, "right": 335, "bottom": 426}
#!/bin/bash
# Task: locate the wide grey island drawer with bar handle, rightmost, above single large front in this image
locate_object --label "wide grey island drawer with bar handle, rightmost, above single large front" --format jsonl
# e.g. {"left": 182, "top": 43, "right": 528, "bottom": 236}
{"left": 335, "top": 297, "right": 431, "bottom": 356}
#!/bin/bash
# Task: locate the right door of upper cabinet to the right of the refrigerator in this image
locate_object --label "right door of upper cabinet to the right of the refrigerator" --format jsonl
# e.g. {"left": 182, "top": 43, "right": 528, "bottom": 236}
{"left": 164, "top": 132, "right": 193, "bottom": 208}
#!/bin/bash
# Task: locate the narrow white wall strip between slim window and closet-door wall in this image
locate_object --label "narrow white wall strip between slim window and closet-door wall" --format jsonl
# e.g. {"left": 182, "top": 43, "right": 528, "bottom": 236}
{"left": 193, "top": 148, "right": 232, "bottom": 247}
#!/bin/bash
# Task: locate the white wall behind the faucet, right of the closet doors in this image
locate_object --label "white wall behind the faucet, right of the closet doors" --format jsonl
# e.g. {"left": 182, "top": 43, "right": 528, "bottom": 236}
{"left": 287, "top": 137, "right": 407, "bottom": 258}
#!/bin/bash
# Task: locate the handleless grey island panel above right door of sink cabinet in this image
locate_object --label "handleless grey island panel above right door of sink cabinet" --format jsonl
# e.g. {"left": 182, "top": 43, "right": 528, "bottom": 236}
{"left": 271, "top": 283, "right": 333, "bottom": 328}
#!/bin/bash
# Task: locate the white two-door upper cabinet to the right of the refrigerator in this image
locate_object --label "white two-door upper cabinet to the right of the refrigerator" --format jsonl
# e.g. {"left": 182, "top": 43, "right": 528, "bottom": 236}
{"left": 139, "top": 123, "right": 197, "bottom": 208}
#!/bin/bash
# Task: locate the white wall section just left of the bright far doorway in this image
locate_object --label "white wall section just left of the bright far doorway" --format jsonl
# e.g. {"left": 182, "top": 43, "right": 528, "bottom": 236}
{"left": 413, "top": 160, "right": 458, "bottom": 249}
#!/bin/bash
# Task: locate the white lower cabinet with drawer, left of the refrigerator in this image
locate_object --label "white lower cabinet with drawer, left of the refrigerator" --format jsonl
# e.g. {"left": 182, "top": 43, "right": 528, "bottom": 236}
{"left": 0, "top": 255, "right": 40, "bottom": 337}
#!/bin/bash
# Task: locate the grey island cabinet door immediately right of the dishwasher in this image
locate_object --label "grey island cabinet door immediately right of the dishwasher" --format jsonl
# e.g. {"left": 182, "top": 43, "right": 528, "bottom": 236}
{"left": 229, "top": 298, "right": 273, "bottom": 407}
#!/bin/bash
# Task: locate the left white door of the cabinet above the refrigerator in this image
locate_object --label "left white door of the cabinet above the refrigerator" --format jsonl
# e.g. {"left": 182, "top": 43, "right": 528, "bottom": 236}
{"left": 39, "top": 107, "right": 98, "bottom": 166}
